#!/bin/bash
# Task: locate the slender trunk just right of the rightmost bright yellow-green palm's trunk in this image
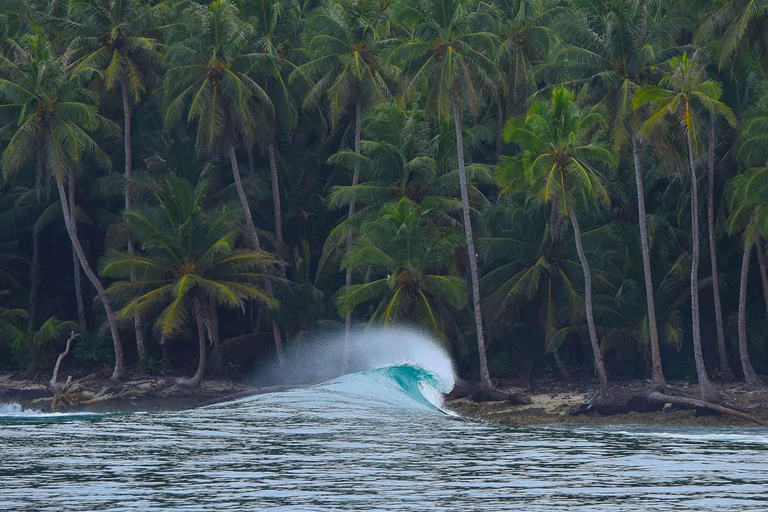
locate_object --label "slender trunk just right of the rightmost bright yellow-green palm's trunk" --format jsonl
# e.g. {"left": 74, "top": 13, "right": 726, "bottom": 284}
{"left": 707, "top": 114, "right": 736, "bottom": 382}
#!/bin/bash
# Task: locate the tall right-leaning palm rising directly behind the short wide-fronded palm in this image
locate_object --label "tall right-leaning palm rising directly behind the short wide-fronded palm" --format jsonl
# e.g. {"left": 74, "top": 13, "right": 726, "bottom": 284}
{"left": 165, "top": 0, "right": 284, "bottom": 365}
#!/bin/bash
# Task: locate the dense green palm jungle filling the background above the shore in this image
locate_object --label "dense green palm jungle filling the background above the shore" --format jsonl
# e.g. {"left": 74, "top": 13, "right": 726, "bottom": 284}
{"left": 0, "top": 0, "right": 768, "bottom": 397}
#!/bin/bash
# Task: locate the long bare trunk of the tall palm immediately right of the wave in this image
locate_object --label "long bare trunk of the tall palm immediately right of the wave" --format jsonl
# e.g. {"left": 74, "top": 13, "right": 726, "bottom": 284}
{"left": 451, "top": 95, "right": 493, "bottom": 391}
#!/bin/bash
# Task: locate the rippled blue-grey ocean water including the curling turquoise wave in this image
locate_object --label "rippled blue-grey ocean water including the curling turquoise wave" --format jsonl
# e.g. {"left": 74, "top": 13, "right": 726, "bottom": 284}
{"left": 0, "top": 330, "right": 768, "bottom": 511}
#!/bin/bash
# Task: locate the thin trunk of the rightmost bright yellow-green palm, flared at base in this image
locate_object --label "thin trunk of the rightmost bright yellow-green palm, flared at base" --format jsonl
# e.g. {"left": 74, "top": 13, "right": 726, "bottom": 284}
{"left": 683, "top": 113, "right": 720, "bottom": 402}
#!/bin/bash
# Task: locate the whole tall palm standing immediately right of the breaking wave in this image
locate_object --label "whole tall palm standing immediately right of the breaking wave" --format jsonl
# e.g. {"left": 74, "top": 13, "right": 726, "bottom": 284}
{"left": 390, "top": 0, "right": 504, "bottom": 390}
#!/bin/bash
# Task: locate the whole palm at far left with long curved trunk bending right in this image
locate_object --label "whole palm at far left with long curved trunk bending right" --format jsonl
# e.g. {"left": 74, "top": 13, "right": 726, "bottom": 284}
{"left": 0, "top": 35, "right": 125, "bottom": 379}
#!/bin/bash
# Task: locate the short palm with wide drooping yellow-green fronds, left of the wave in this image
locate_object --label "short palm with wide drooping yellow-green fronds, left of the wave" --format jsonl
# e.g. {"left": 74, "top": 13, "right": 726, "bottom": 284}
{"left": 99, "top": 178, "right": 277, "bottom": 386}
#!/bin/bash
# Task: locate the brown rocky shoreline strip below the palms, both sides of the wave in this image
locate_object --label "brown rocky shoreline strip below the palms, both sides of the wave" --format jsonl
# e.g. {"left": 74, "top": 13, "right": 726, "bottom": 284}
{"left": 0, "top": 374, "right": 768, "bottom": 427}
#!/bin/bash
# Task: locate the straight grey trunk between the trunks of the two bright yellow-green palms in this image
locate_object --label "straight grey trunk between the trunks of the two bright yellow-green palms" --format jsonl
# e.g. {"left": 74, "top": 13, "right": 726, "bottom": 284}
{"left": 632, "top": 126, "right": 666, "bottom": 389}
